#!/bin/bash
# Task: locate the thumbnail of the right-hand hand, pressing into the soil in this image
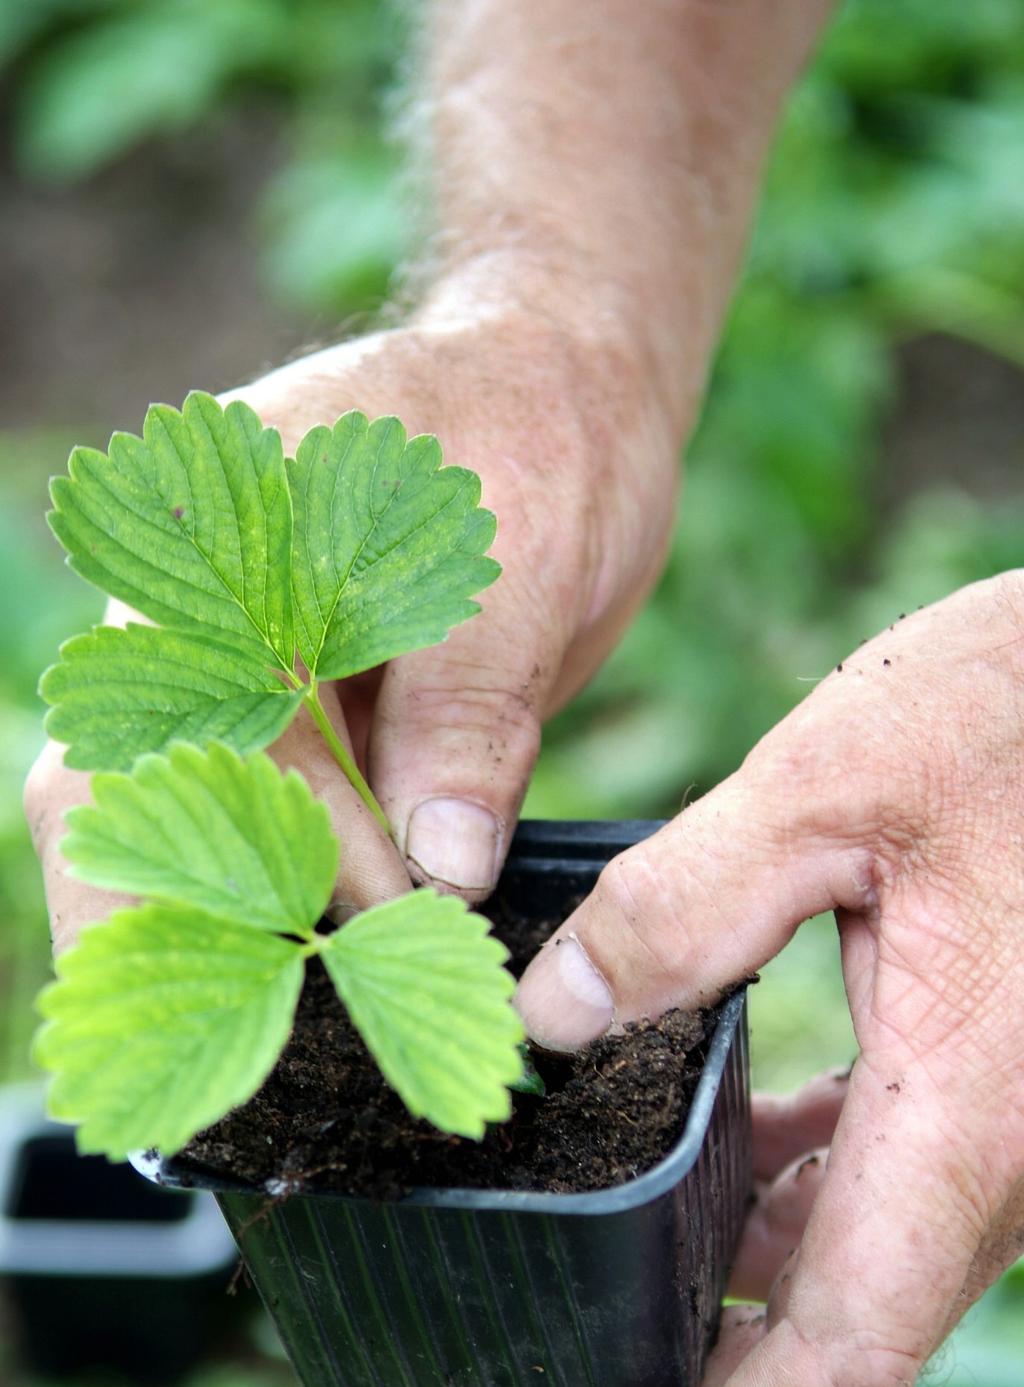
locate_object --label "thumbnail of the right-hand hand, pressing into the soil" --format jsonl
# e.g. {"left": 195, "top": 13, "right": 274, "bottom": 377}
{"left": 513, "top": 935, "right": 615, "bottom": 1050}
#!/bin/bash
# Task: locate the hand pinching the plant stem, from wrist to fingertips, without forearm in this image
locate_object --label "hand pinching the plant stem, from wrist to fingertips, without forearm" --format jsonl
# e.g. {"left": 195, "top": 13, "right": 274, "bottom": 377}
{"left": 26, "top": 300, "right": 679, "bottom": 947}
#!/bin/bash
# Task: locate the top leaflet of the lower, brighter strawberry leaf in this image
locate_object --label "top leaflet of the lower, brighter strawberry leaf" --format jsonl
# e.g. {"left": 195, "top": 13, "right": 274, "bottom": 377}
{"left": 61, "top": 743, "right": 337, "bottom": 938}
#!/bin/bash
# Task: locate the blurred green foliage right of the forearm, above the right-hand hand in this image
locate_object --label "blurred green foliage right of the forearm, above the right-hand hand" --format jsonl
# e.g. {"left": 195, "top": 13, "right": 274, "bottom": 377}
{"left": 527, "top": 0, "right": 1024, "bottom": 814}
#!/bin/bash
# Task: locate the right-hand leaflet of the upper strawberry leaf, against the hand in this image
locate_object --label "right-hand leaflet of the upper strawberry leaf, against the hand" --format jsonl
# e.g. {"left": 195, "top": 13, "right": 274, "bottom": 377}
{"left": 289, "top": 411, "right": 501, "bottom": 680}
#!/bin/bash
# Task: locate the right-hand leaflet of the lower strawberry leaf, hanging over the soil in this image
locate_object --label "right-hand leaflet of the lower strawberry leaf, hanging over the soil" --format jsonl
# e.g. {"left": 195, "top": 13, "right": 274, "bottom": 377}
{"left": 321, "top": 890, "right": 523, "bottom": 1139}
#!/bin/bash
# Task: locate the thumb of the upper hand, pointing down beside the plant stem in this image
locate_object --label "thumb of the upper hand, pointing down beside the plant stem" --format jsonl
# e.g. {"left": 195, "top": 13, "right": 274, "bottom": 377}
{"left": 368, "top": 595, "right": 558, "bottom": 902}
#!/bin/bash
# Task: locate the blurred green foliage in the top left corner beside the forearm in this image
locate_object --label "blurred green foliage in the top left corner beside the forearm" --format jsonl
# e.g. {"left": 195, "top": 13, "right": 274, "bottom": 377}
{"left": 0, "top": 0, "right": 405, "bottom": 315}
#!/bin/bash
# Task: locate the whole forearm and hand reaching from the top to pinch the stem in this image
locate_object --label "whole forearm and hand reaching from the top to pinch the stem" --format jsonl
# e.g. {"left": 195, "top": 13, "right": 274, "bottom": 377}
{"left": 26, "top": 0, "right": 826, "bottom": 949}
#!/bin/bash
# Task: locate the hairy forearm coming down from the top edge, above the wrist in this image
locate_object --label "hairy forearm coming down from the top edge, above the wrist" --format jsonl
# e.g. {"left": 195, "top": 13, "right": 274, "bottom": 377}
{"left": 407, "top": 0, "right": 827, "bottom": 424}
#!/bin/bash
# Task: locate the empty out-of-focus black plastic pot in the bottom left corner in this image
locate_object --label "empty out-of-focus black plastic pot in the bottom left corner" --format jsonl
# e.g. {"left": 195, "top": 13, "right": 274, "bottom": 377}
{"left": 0, "top": 1085, "right": 237, "bottom": 1384}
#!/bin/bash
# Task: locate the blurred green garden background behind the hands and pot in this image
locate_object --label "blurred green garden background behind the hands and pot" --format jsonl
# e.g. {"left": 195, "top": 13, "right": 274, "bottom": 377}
{"left": 0, "top": 0, "right": 1024, "bottom": 1387}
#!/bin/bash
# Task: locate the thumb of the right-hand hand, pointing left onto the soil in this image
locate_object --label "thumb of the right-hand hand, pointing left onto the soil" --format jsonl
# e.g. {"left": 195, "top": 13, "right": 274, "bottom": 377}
{"left": 516, "top": 768, "right": 870, "bottom": 1050}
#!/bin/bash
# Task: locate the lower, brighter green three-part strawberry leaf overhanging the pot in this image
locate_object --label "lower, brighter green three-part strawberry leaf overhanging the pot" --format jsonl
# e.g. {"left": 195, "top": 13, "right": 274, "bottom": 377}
{"left": 35, "top": 743, "right": 523, "bottom": 1160}
